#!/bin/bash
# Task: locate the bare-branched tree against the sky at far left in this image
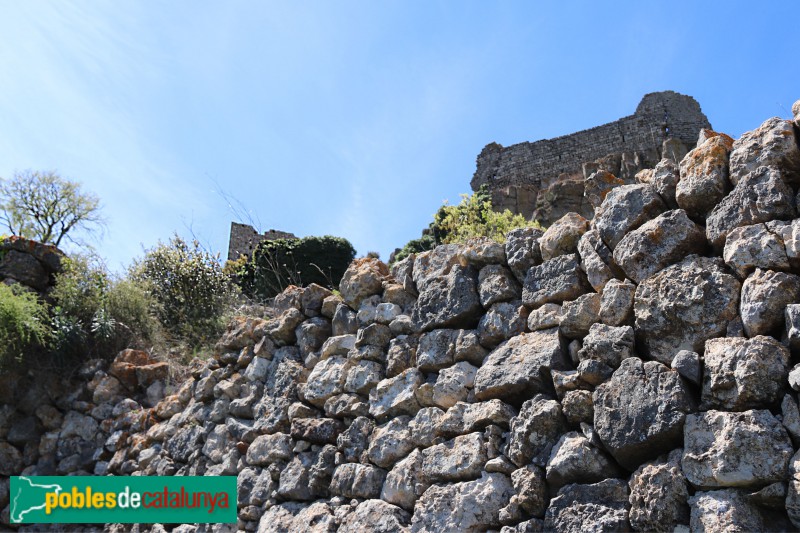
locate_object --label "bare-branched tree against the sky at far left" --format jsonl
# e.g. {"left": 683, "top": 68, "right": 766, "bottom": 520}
{"left": 0, "top": 170, "right": 103, "bottom": 246}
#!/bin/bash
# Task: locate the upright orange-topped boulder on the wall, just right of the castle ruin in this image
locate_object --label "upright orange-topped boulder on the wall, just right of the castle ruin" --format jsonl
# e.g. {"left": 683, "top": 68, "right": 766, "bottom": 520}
{"left": 675, "top": 130, "right": 733, "bottom": 219}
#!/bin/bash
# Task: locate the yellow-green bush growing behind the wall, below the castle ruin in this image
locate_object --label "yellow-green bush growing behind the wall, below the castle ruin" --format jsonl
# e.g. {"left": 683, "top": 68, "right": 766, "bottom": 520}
{"left": 394, "top": 185, "right": 541, "bottom": 261}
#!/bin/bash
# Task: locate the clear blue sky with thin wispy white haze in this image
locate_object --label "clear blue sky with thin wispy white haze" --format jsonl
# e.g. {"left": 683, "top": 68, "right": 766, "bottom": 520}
{"left": 0, "top": 0, "right": 800, "bottom": 270}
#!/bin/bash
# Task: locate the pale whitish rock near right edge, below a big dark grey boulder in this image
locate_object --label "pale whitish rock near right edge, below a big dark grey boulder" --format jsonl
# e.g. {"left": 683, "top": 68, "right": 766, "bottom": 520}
{"left": 722, "top": 222, "right": 789, "bottom": 279}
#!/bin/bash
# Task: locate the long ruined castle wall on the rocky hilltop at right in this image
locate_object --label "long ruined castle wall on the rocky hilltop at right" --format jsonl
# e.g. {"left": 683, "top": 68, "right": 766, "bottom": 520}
{"left": 470, "top": 91, "right": 711, "bottom": 224}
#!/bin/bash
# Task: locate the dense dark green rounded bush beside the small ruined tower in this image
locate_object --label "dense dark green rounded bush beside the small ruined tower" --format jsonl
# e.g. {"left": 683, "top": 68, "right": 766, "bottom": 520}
{"left": 236, "top": 235, "right": 356, "bottom": 299}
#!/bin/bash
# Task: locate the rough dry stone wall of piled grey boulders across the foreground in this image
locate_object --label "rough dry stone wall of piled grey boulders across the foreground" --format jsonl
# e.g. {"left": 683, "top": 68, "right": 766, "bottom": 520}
{"left": 0, "top": 104, "right": 800, "bottom": 533}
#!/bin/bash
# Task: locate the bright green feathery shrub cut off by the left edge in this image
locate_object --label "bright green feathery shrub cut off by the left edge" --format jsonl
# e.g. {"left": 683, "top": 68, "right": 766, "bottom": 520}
{"left": 0, "top": 284, "right": 50, "bottom": 366}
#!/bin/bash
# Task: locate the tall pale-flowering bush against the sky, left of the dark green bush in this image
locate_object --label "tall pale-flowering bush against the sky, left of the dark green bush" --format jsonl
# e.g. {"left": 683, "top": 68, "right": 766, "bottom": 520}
{"left": 130, "top": 235, "right": 236, "bottom": 347}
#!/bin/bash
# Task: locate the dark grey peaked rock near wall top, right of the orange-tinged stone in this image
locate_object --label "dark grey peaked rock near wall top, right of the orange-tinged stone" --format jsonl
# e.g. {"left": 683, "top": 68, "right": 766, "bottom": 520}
{"left": 412, "top": 265, "right": 483, "bottom": 331}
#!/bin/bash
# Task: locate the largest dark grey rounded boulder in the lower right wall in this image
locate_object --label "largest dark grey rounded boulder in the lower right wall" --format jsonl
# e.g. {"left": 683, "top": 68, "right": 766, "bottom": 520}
{"left": 592, "top": 357, "right": 695, "bottom": 470}
